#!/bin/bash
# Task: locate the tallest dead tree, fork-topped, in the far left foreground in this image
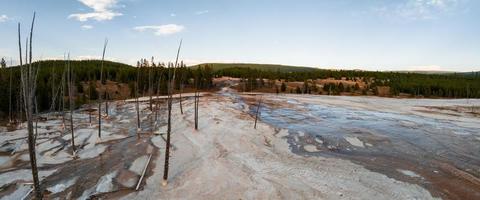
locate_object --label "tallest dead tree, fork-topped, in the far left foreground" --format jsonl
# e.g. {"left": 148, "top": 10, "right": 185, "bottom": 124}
{"left": 18, "top": 12, "right": 42, "bottom": 199}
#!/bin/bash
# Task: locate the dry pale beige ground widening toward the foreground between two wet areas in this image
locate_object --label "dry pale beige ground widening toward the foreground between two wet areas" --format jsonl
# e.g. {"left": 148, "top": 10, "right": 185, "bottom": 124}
{"left": 124, "top": 89, "right": 438, "bottom": 199}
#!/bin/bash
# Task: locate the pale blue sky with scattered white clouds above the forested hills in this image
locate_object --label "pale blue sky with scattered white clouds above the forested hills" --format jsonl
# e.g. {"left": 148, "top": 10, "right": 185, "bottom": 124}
{"left": 0, "top": 0, "right": 480, "bottom": 71}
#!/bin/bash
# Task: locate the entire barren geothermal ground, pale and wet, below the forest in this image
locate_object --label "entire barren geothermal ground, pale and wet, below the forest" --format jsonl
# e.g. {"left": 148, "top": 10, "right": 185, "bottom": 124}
{"left": 0, "top": 88, "right": 480, "bottom": 199}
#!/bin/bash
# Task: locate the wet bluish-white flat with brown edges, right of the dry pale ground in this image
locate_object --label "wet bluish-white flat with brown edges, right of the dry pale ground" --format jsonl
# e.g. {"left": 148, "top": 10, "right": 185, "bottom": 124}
{"left": 241, "top": 95, "right": 480, "bottom": 199}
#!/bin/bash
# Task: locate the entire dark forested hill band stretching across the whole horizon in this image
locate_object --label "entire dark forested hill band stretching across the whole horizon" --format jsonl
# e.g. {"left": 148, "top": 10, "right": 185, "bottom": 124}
{"left": 0, "top": 59, "right": 480, "bottom": 118}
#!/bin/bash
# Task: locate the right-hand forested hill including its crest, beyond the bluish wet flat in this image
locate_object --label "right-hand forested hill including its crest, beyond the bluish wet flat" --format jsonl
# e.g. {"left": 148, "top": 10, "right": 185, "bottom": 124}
{"left": 206, "top": 64, "right": 480, "bottom": 98}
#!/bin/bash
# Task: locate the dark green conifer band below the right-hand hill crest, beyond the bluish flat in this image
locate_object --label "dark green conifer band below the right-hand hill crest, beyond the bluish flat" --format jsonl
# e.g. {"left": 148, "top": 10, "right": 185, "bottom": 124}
{"left": 215, "top": 66, "right": 480, "bottom": 98}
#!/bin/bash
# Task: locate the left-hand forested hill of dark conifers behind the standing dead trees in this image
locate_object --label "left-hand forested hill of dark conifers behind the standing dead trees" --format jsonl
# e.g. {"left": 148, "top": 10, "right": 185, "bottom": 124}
{"left": 0, "top": 59, "right": 213, "bottom": 118}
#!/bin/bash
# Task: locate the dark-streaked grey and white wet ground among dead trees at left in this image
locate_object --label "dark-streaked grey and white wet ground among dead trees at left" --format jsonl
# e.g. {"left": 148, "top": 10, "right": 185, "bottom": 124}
{"left": 0, "top": 101, "right": 165, "bottom": 199}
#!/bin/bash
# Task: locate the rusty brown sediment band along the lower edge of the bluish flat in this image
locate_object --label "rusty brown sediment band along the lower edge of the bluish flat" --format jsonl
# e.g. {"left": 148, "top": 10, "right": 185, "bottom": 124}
{"left": 288, "top": 131, "right": 480, "bottom": 200}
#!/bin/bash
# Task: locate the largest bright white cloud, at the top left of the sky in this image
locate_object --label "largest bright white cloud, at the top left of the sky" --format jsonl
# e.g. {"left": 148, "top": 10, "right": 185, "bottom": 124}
{"left": 68, "top": 0, "right": 123, "bottom": 22}
